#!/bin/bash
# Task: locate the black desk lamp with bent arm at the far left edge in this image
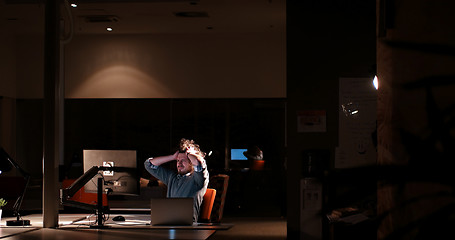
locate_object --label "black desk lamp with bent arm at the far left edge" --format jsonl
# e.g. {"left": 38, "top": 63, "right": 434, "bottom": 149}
{"left": 0, "top": 147, "right": 30, "bottom": 226}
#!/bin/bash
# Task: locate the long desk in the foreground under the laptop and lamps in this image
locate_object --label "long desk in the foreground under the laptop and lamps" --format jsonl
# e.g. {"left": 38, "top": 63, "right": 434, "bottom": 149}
{"left": 0, "top": 214, "right": 231, "bottom": 240}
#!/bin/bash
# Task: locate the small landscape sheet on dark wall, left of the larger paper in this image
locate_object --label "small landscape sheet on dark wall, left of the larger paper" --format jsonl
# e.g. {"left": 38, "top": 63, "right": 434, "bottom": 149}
{"left": 297, "top": 110, "right": 327, "bottom": 132}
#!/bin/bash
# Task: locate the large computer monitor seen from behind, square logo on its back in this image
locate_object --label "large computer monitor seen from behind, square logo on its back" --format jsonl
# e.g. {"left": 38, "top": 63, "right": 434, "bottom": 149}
{"left": 83, "top": 150, "right": 140, "bottom": 195}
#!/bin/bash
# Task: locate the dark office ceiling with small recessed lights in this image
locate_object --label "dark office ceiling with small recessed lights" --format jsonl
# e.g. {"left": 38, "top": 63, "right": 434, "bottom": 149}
{"left": 0, "top": 0, "right": 286, "bottom": 34}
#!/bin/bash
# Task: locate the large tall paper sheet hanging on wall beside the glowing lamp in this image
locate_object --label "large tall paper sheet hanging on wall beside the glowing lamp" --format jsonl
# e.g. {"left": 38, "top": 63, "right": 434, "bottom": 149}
{"left": 335, "top": 78, "right": 377, "bottom": 168}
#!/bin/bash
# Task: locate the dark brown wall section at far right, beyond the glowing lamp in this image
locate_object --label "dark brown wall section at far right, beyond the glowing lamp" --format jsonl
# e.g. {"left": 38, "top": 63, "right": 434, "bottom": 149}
{"left": 377, "top": 0, "right": 455, "bottom": 239}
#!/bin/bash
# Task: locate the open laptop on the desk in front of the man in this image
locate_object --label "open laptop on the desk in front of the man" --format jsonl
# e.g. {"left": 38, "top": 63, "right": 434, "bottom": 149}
{"left": 150, "top": 198, "right": 193, "bottom": 226}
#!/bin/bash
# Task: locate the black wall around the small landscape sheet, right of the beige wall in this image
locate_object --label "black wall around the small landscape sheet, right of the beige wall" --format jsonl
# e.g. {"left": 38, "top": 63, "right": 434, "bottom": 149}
{"left": 287, "top": 0, "right": 376, "bottom": 239}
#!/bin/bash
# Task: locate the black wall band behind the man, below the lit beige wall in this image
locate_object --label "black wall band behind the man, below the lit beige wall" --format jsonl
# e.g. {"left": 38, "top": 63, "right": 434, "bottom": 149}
{"left": 65, "top": 99, "right": 284, "bottom": 172}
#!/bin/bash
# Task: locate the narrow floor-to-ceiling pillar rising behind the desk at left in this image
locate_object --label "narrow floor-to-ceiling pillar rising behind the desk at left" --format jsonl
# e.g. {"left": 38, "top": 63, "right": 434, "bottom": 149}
{"left": 43, "top": 0, "right": 62, "bottom": 228}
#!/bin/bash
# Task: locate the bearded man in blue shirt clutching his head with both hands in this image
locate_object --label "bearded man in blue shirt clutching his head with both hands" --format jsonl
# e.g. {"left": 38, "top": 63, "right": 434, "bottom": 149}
{"left": 144, "top": 138, "right": 209, "bottom": 222}
